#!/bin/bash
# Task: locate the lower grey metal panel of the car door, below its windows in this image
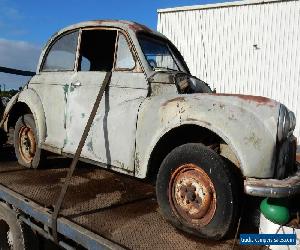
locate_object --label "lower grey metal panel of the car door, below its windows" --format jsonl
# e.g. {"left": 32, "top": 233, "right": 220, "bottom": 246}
{"left": 63, "top": 71, "right": 148, "bottom": 174}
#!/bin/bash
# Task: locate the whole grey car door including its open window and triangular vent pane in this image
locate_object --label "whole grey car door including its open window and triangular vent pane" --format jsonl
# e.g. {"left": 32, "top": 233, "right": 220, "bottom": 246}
{"left": 64, "top": 29, "right": 148, "bottom": 173}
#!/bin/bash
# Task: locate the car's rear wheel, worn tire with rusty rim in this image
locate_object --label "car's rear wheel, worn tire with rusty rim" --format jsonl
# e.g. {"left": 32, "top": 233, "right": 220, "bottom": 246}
{"left": 14, "top": 114, "right": 45, "bottom": 168}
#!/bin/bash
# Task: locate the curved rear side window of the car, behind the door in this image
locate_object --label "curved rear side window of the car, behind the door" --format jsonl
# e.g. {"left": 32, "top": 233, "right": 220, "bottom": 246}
{"left": 42, "top": 31, "right": 78, "bottom": 71}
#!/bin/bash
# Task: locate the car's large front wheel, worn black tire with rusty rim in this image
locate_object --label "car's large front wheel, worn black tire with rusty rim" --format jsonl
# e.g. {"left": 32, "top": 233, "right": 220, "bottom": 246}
{"left": 156, "top": 143, "right": 240, "bottom": 240}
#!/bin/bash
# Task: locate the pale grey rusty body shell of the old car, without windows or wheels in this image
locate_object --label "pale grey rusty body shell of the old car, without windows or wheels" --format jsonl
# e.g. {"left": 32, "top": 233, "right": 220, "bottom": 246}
{"left": 2, "top": 20, "right": 280, "bottom": 178}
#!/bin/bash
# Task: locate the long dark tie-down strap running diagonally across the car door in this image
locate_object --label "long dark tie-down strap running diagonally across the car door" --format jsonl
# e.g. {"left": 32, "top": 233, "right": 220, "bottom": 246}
{"left": 52, "top": 72, "right": 112, "bottom": 242}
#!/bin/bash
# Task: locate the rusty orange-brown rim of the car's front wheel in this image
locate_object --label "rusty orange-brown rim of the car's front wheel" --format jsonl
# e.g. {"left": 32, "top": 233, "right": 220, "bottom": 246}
{"left": 169, "top": 164, "right": 217, "bottom": 226}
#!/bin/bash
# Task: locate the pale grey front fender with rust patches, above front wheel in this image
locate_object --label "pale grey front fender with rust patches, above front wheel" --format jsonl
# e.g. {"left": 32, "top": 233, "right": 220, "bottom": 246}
{"left": 136, "top": 93, "right": 279, "bottom": 178}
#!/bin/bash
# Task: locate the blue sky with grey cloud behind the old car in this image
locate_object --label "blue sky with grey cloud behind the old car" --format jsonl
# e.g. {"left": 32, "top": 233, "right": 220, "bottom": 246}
{"left": 0, "top": 0, "right": 232, "bottom": 89}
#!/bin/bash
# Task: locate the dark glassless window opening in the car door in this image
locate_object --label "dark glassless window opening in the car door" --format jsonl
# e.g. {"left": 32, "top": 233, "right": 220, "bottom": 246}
{"left": 78, "top": 30, "right": 117, "bottom": 71}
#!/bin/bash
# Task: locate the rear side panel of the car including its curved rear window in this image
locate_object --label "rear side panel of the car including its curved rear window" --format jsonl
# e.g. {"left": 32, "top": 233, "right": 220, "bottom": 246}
{"left": 30, "top": 30, "right": 79, "bottom": 150}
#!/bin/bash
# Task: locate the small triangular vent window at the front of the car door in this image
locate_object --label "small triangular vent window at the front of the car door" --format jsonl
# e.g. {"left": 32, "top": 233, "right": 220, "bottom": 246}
{"left": 116, "top": 32, "right": 135, "bottom": 70}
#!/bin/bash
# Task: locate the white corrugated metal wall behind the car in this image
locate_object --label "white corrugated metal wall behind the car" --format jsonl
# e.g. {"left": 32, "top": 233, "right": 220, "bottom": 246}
{"left": 158, "top": 1, "right": 300, "bottom": 142}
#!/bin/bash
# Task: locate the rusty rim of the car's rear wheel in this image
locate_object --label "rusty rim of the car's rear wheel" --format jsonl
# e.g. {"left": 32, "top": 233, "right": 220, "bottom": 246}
{"left": 19, "top": 126, "right": 36, "bottom": 163}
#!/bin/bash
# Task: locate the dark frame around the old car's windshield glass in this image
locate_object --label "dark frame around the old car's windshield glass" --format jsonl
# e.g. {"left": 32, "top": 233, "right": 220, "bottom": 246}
{"left": 136, "top": 32, "right": 190, "bottom": 74}
